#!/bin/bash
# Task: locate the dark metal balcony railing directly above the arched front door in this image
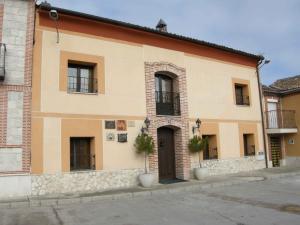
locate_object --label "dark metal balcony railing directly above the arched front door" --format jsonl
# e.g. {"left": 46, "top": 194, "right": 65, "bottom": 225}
{"left": 155, "top": 91, "right": 180, "bottom": 116}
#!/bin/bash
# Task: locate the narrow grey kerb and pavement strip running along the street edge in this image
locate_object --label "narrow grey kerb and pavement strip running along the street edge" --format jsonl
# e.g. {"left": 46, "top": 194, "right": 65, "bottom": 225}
{"left": 0, "top": 172, "right": 300, "bottom": 209}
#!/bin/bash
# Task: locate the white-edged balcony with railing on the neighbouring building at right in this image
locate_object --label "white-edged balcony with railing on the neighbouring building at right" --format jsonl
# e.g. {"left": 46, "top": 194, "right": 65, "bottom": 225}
{"left": 266, "top": 110, "right": 298, "bottom": 134}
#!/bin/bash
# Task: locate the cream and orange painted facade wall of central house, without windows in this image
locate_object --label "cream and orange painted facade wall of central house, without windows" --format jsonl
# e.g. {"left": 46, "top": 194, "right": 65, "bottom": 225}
{"left": 32, "top": 6, "right": 264, "bottom": 192}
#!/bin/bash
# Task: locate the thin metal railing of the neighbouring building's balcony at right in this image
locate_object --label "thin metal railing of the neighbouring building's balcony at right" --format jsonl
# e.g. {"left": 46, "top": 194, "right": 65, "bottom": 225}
{"left": 266, "top": 110, "right": 297, "bottom": 129}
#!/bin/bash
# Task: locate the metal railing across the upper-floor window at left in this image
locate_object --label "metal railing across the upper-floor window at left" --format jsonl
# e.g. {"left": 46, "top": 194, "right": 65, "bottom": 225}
{"left": 68, "top": 76, "right": 98, "bottom": 93}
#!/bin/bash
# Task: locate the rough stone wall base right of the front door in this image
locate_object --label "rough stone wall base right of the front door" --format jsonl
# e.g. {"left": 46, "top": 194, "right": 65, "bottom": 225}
{"left": 192, "top": 156, "right": 266, "bottom": 176}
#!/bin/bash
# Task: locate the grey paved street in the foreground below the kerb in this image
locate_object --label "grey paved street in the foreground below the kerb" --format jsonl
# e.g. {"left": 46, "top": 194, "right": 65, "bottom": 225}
{"left": 0, "top": 176, "right": 300, "bottom": 225}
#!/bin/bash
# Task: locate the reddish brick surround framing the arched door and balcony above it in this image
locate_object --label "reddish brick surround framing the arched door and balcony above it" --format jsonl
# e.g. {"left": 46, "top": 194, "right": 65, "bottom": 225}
{"left": 145, "top": 62, "right": 191, "bottom": 180}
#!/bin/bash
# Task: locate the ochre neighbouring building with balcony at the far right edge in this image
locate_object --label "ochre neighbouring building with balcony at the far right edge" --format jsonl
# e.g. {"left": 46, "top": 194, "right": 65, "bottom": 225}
{"left": 263, "top": 76, "right": 300, "bottom": 166}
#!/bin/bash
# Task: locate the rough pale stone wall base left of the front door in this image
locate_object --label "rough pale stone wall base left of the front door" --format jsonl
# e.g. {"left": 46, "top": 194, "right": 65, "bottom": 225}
{"left": 31, "top": 169, "right": 144, "bottom": 195}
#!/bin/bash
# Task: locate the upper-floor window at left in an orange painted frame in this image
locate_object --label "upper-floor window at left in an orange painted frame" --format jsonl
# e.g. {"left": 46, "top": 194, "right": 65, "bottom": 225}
{"left": 68, "top": 63, "right": 97, "bottom": 93}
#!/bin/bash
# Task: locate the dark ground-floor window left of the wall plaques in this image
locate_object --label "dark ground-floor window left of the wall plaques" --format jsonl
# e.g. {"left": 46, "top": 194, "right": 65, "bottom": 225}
{"left": 70, "top": 137, "right": 93, "bottom": 170}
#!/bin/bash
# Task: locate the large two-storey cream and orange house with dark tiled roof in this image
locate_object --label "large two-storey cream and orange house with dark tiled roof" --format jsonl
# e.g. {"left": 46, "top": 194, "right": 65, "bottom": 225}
{"left": 32, "top": 6, "right": 265, "bottom": 194}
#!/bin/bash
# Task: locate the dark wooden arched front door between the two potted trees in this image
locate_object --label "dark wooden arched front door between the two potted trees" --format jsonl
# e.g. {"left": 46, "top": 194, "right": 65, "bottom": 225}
{"left": 157, "top": 127, "right": 176, "bottom": 180}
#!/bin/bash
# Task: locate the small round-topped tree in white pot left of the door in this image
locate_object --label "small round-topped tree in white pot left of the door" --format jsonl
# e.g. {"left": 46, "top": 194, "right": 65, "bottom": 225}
{"left": 134, "top": 133, "right": 154, "bottom": 188}
